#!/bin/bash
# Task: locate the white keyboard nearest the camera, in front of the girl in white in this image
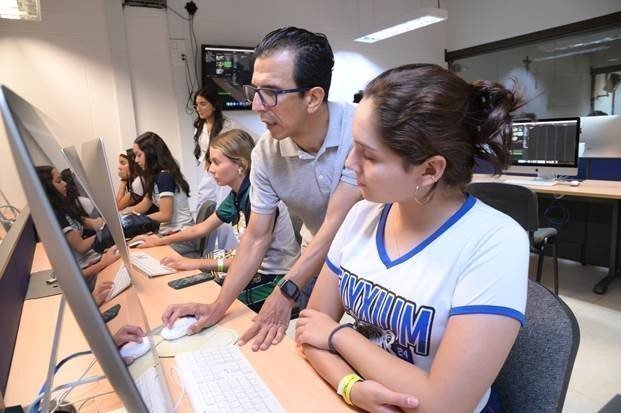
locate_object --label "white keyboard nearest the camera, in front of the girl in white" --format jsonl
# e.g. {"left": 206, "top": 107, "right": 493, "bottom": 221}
{"left": 175, "top": 345, "right": 285, "bottom": 413}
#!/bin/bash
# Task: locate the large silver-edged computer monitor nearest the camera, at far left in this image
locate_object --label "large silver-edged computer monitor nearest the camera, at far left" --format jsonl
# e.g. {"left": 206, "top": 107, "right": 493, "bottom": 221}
{"left": 0, "top": 86, "right": 172, "bottom": 412}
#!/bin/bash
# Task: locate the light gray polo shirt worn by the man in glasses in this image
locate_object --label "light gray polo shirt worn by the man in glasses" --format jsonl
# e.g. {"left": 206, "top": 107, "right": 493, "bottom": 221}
{"left": 250, "top": 102, "right": 356, "bottom": 241}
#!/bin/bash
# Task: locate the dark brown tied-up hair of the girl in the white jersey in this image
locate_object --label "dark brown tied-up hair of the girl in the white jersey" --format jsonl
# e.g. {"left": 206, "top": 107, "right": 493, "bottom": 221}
{"left": 364, "top": 64, "right": 522, "bottom": 188}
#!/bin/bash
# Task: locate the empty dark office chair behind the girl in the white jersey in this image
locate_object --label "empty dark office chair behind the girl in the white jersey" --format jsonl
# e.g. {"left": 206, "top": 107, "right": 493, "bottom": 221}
{"left": 466, "top": 182, "right": 558, "bottom": 294}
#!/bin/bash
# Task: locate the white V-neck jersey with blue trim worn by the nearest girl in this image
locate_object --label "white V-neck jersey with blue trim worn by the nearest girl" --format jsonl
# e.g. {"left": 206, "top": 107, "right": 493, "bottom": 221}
{"left": 327, "top": 196, "right": 529, "bottom": 408}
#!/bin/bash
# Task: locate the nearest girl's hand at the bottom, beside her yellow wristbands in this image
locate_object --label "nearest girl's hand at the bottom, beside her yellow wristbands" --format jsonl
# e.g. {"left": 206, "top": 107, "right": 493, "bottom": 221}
{"left": 350, "top": 380, "right": 418, "bottom": 413}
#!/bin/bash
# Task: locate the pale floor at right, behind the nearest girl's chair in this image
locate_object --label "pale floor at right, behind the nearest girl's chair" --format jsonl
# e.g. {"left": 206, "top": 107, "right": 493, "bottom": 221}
{"left": 287, "top": 257, "right": 621, "bottom": 413}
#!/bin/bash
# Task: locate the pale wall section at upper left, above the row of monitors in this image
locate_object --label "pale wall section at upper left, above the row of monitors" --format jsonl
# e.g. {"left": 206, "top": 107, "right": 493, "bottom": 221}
{"left": 0, "top": 0, "right": 126, "bottom": 207}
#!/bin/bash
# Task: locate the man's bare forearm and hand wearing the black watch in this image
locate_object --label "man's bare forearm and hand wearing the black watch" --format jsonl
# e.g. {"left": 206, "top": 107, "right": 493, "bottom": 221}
{"left": 239, "top": 182, "right": 361, "bottom": 351}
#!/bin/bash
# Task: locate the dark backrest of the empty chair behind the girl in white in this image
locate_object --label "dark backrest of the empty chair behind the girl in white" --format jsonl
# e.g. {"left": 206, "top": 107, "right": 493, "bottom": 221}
{"left": 466, "top": 182, "right": 539, "bottom": 233}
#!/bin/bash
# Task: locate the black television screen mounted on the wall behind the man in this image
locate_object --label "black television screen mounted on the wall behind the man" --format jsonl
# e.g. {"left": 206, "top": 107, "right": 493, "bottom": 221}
{"left": 201, "top": 45, "right": 254, "bottom": 110}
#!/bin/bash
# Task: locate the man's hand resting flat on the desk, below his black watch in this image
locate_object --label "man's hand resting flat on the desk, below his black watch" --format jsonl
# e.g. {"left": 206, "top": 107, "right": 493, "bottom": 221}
{"left": 237, "top": 288, "right": 293, "bottom": 351}
